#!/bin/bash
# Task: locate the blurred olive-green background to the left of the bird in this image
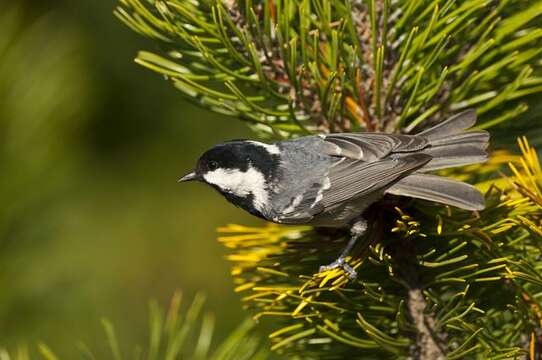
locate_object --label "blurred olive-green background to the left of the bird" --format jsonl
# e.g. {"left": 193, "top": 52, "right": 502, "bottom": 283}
{"left": 0, "top": 0, "right": 255, "bottom": 358}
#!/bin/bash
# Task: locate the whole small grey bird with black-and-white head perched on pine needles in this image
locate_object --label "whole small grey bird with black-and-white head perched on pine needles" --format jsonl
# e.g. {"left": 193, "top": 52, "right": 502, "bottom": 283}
{"left": 179, "top": 109, "right": 489, "bottom": 279}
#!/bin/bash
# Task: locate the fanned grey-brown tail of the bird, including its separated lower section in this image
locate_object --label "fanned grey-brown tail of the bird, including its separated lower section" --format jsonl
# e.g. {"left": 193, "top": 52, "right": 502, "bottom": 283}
{"left": 386, "top": 110, "right": 489, "bottom": 210}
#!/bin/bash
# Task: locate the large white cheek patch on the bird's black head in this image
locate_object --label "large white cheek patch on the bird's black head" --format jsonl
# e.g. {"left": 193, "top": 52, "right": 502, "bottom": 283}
{"left": 203, "top": 166, "right": 269, "bottom": 211}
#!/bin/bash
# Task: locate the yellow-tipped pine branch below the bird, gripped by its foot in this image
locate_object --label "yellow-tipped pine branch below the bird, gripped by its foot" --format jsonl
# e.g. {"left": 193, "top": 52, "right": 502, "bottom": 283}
{"left": 219, "top": 143, "right": 542, "bottom": 359}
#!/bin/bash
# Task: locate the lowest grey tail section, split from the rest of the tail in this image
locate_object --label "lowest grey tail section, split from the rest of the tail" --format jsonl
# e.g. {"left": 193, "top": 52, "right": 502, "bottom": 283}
{"left": 386, "top": 174, "right": 485, "bottom": 211}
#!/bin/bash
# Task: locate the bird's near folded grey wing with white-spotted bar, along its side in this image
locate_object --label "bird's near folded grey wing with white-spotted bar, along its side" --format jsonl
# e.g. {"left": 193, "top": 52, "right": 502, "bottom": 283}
{"left": 274, "top": 154, "right": 431, "bottom": 224}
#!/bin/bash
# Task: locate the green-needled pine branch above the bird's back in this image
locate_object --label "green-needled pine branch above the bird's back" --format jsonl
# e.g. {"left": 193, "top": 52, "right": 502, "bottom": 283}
{"left": 115, "top": 0, "right": 542, "bottom": 136}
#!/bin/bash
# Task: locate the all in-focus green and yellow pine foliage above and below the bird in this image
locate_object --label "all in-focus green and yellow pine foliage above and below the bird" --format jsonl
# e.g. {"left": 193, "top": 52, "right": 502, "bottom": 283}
{"left": 115, "top": 0, "right": 542, "bottom": 359}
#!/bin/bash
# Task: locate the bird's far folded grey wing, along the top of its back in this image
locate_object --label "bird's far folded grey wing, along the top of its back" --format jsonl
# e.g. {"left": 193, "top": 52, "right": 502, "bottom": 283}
{"left": 322, "top": 133, "right": 428, "bottom": 162}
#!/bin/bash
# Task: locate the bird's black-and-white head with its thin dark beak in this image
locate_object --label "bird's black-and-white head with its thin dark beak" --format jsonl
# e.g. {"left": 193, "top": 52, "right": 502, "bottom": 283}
{"left": 180, "top": 140, "right": 280, "bottom": 213}
